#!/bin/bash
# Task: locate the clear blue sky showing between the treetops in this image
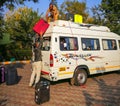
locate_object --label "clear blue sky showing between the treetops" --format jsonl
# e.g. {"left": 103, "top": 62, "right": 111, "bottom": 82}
{"left": 22, "top": 0, "right": 101, "bottom": 15}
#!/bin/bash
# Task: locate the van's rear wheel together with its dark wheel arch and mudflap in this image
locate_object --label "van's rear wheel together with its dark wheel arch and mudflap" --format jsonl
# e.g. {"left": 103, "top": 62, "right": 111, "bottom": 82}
{"left": 70, "top": 65, "right": 89, "bottom": 86}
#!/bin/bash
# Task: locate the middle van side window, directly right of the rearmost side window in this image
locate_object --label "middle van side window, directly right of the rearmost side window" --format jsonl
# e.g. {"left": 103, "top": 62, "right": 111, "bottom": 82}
{"left": 81, "top": 38, "right": 100, "bottom": 50}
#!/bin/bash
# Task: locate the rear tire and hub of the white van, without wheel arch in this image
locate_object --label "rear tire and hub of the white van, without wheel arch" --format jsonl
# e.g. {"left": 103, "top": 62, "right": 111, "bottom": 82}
{"left": 74, "top": 68, "right": 87, "bottom": 86}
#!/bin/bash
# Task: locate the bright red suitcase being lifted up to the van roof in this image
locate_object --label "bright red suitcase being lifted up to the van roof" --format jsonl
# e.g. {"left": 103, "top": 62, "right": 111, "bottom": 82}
{"left": 33, "top": 19, "right": 49, "bottom": 36}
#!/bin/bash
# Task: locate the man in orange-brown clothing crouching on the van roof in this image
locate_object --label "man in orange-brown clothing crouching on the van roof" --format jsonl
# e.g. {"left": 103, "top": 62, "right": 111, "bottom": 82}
{"left": 46, "top": 2, "right": 59, "bottom": 23}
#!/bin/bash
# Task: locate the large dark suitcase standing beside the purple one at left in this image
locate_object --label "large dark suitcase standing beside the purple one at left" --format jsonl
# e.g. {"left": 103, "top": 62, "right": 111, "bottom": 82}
{"left": 5, "top": 66, "right": 18, "bottom": 85}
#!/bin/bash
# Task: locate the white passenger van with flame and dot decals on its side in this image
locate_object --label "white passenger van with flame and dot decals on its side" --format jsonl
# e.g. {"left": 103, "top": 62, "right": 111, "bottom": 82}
{"left": 42, "top": 20, "right": 120, "bottom": 86}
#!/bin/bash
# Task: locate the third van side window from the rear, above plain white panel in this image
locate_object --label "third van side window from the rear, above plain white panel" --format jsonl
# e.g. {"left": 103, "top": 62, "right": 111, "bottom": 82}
{"left": 102, "top": 39, "right": 117, "bottom": 50}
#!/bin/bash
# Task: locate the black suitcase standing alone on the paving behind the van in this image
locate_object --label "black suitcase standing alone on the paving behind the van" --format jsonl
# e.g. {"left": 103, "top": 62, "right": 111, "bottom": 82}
{"left": 35, "top": 80, "right": 50, "bottom": 104}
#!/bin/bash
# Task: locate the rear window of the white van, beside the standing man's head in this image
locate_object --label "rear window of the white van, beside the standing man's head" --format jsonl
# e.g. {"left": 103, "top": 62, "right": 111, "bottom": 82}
{"left": 42, "top": 37, "right": 51, "bottom": 51}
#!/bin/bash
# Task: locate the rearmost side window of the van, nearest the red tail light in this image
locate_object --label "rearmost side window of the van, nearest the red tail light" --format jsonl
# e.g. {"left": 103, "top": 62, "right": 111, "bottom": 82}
{"left": 60, "top": 37, "right": 78, "bottom": 51}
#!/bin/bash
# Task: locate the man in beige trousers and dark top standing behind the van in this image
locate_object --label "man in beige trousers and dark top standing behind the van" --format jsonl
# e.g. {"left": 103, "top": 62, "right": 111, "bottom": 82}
{"left": 29, "top": 35, "right": 42, "bottom": 87}
